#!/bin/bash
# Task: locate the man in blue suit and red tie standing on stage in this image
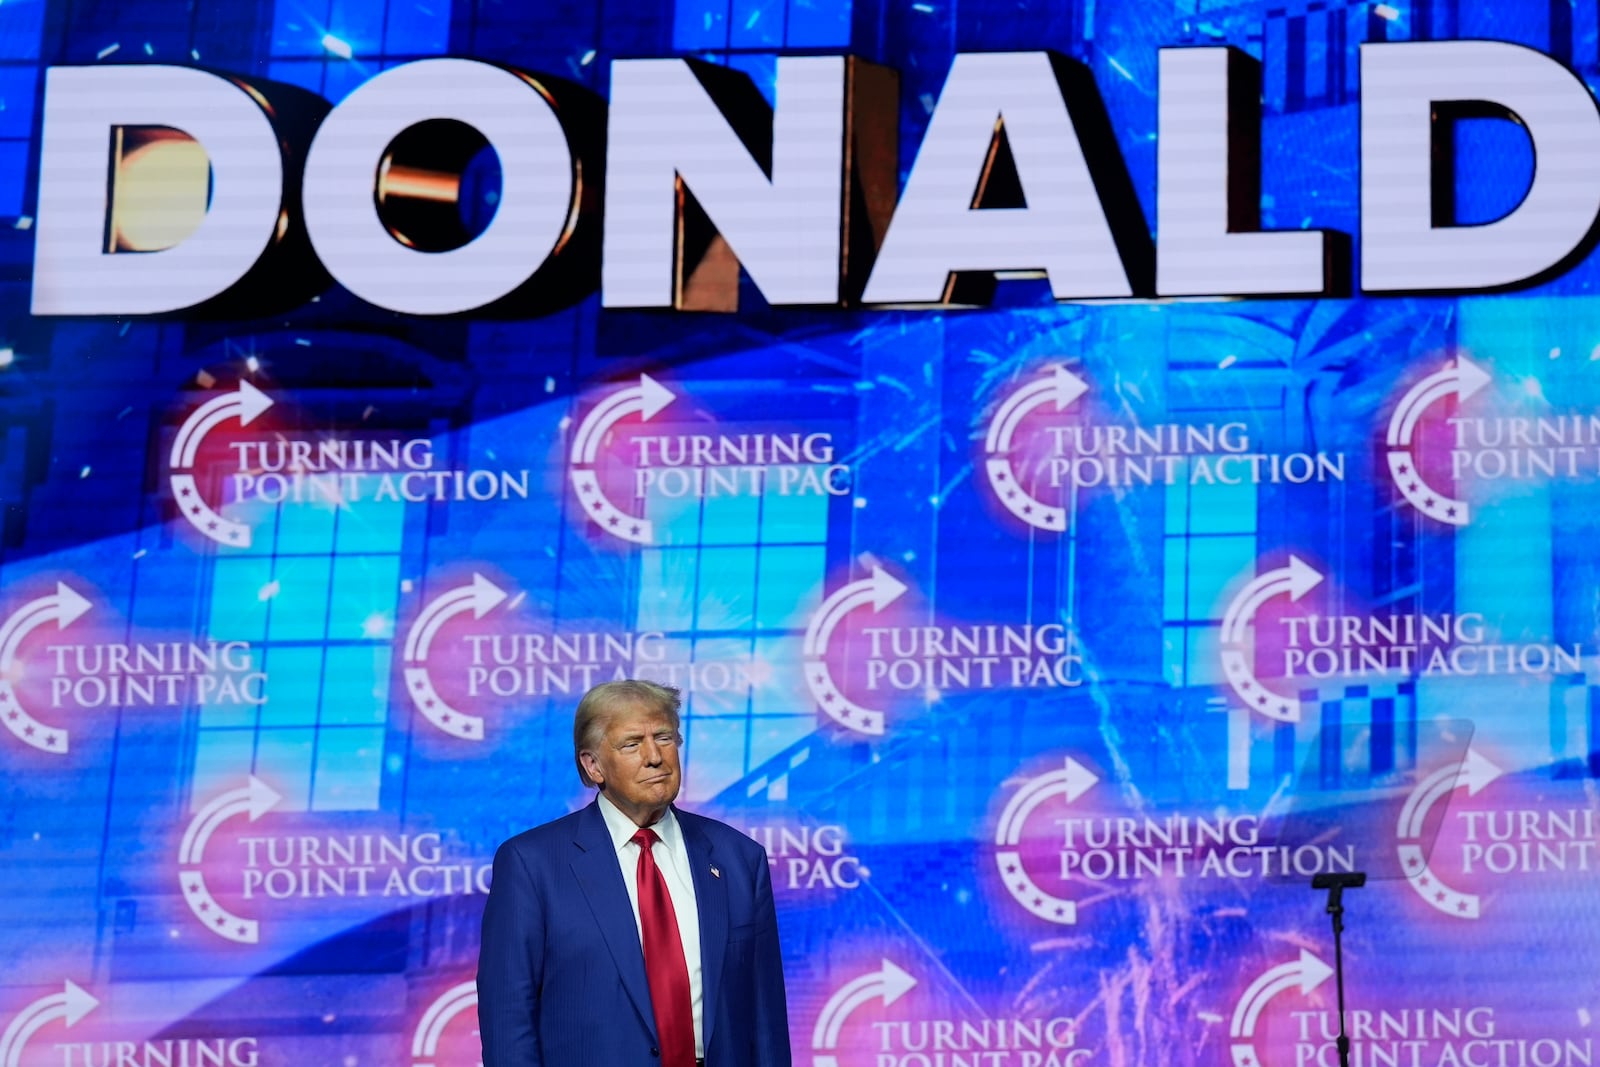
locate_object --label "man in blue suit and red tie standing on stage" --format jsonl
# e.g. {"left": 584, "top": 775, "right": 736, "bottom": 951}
{"left": 478, "top": 681, "right": 790, "bottom": 1067}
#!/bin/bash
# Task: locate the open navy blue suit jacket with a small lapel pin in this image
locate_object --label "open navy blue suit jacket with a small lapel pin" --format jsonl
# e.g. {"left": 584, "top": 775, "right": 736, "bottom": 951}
{"left": 478, "top": 801, "right": 790, "bottom": 1067}
